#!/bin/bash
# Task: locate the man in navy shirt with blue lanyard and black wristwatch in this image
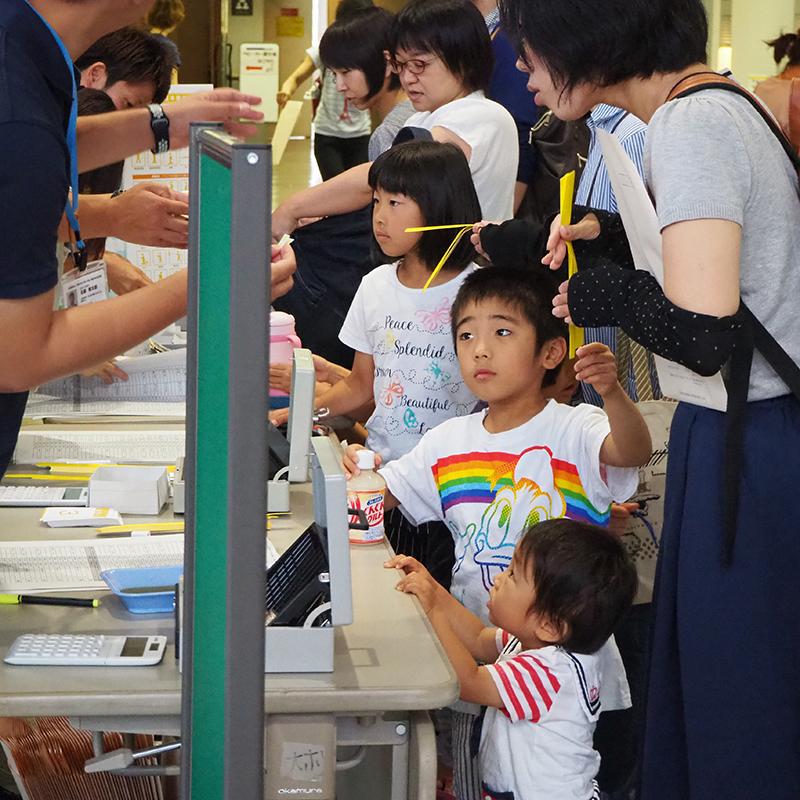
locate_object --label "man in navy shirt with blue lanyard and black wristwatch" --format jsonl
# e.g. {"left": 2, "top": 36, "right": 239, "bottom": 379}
{"left": 0, "top": 0, "right": 292, "bottom": 474}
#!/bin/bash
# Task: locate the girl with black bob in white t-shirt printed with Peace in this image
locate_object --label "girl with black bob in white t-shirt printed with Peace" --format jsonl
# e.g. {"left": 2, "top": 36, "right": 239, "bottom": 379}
{"left": 312, "top": 141, "right": 481, "bottom": 586}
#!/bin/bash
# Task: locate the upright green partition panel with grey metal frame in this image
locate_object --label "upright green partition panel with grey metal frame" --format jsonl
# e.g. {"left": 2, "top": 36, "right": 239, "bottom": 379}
{"left": 181, "top": 126, "right": 271, "bottom": 800}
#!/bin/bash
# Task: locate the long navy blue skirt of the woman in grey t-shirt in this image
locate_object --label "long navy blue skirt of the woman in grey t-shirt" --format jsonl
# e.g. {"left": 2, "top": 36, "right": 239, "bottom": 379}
{"left": 641, "top": 397, "right": 800, "bottom": 800}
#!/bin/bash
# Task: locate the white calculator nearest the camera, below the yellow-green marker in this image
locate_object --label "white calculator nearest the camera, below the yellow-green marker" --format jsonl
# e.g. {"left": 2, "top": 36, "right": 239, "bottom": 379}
{"left": 4, "top": 633, "right": 167, "bottom": 667}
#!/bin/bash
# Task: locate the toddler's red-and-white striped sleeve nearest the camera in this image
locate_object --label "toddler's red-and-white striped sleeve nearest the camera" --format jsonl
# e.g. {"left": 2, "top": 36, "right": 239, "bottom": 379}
{"left": 486, "top": 648, "right": 561, "bottom": 722}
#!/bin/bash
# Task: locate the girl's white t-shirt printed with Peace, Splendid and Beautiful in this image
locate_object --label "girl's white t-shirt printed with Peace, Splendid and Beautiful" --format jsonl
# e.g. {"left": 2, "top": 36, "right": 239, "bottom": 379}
{"left": 339, "top": 262, "right": 477, "bottom": 463}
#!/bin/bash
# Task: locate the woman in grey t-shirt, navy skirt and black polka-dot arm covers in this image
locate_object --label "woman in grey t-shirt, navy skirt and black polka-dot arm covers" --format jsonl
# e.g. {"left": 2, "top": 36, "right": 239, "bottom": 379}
{"left": 501, "top": 0, "right": 800, "bottom": 800}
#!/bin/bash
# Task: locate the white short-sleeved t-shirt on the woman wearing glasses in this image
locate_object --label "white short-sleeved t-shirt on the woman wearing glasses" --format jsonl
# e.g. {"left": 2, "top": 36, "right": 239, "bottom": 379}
{"left": 405, "top": 92, "right": 519, "bottom": 220}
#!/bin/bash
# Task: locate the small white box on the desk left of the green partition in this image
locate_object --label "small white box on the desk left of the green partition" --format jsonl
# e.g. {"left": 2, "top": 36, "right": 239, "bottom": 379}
{"left": 89, "top": 466, "right": 169, "bottom": 514}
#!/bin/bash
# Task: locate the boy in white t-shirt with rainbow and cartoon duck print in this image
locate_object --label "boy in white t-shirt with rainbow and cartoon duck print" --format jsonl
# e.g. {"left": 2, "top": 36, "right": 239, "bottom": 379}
{"left": 344, "top": 267, "right": 651, "bottom": 800}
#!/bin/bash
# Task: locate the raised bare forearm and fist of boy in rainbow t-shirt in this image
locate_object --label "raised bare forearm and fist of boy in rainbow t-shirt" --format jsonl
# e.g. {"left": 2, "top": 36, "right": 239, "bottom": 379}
{"left": 575, "top": 342, "right": 653, "bottom": 467}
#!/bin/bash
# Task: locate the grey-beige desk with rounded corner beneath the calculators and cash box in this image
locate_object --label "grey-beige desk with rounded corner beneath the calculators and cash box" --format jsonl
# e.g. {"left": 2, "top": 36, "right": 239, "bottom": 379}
{"left": 0, "top": 478, "right": 458, "bottom": 800}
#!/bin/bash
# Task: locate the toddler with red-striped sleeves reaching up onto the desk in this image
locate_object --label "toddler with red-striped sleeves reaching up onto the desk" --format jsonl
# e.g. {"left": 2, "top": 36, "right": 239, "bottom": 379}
{"left": 386, "top": 519, "right": 636, "bottom": 800}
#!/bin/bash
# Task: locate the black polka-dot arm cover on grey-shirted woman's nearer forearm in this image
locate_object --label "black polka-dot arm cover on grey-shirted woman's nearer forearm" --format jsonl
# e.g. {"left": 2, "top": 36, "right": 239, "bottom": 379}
{"left": 569, "top": 266, "right": 741, "bottom": 375}
